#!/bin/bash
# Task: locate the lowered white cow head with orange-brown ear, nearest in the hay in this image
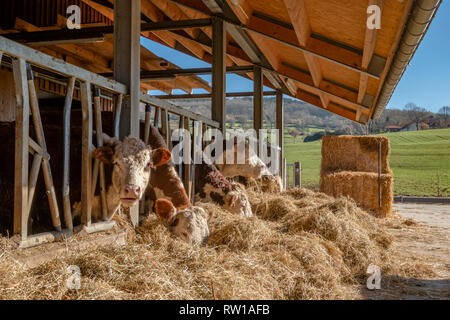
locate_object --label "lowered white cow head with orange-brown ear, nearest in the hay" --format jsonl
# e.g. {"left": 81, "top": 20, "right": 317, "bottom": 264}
{"left": 155, "top": 199, "right": 211, "bottom": 245}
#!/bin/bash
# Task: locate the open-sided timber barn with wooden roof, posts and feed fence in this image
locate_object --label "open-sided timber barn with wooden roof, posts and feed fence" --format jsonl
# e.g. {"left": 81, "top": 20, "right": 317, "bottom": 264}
{"left": 0, "top": 0, "right": 441, "bottom": 247}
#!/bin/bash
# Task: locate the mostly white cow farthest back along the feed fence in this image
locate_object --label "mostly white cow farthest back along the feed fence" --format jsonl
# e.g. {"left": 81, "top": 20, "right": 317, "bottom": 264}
{"left": 215, "top": 142, "right": 283, "bottom": 192}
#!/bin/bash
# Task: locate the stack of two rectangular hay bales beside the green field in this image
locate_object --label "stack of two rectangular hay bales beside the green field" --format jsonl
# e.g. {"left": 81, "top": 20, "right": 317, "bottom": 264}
{"left": 320, "top": 136, "right": 394, "bottom": 217}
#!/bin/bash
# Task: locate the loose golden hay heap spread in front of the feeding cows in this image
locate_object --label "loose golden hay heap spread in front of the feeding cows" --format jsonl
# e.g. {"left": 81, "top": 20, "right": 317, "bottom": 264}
{"left": 0, "top": 189, "right": 391, "bottom": 299}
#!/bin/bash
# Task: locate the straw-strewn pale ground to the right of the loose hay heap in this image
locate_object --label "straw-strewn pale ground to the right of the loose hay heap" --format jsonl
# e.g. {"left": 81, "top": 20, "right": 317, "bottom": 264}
{"left": 364, "top": 204, "right": 450, "bottom": 299}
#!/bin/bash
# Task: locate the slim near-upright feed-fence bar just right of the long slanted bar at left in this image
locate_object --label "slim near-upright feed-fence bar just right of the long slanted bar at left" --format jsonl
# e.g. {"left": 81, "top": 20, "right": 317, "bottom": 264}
{"left": 62, "top": 77, "right": 75, "bottom": 230}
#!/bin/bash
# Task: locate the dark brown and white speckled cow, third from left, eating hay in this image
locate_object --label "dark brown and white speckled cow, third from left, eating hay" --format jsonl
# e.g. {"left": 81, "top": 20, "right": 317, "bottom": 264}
{"left": 195, "top": 163, "right": 253, "bottom": 217}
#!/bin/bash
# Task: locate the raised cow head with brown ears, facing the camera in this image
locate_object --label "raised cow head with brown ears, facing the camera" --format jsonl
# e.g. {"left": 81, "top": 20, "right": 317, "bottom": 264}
{"left": 94, "top": 137, "right": 172, "bottom": 207}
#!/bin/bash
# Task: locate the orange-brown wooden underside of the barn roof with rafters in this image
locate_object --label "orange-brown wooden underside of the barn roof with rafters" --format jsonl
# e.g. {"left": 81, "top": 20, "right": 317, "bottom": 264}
{"left": 0, "top": 0, "right": 428, "bottom": 123}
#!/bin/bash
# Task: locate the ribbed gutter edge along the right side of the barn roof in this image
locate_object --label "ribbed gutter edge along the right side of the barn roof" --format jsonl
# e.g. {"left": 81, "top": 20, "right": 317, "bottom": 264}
{"left": 372, "top": 0, "right": 442, "bottom": 119}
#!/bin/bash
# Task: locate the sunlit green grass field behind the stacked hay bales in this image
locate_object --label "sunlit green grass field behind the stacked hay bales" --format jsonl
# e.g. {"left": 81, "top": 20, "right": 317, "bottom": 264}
{"left": 285, "top": 129, "right": 450, "bottom": 197}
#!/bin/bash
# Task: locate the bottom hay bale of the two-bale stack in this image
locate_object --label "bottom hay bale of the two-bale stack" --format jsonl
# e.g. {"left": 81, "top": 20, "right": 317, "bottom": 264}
{"left": 320, "top": 171, "right": 394, "bottom": 217}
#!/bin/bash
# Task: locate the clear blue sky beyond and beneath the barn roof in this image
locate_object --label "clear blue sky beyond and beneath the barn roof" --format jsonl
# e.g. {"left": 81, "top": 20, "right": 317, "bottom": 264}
{"left": 141, "top": 0, "right": 450, "bottom": 112}
